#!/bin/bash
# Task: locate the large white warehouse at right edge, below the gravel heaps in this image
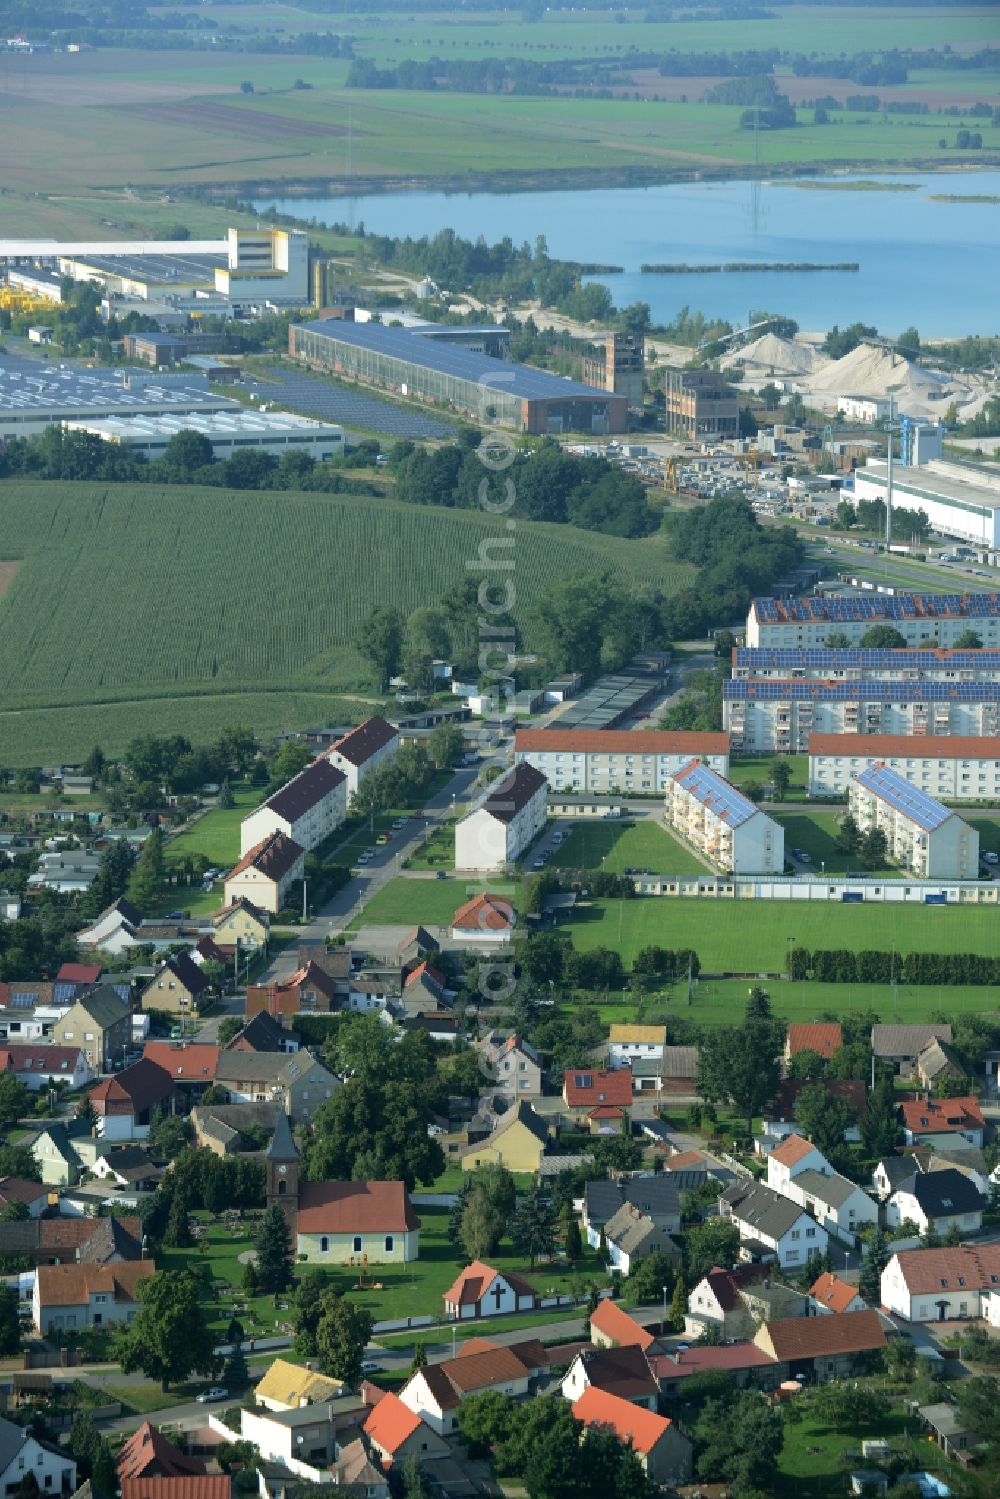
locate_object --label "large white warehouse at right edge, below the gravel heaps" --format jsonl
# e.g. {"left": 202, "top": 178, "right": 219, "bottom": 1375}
{"left": 855, "top": 459, "right": 1000, "bottom": 549}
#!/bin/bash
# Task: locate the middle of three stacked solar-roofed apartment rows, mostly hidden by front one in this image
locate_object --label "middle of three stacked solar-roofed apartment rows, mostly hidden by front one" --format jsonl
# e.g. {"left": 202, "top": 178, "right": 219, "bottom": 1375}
{"left": 733, "top": 646, "right": 1000, "bottom": 682}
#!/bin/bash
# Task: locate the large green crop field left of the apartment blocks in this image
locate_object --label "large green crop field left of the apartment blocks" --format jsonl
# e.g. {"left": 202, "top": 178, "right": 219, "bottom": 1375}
{"left": 0, "top": 483, "right": 691, "bottom": 764}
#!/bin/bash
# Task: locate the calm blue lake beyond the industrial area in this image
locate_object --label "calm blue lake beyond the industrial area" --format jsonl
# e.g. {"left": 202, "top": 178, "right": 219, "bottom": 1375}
{"left": 256, "top": 172, "right": 1000, "bottom": 336}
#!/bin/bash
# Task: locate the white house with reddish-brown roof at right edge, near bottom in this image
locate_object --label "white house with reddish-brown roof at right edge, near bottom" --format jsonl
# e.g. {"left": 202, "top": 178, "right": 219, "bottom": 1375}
{"left": 882, "top": 1244, "right": 1000, "bottom": 1322}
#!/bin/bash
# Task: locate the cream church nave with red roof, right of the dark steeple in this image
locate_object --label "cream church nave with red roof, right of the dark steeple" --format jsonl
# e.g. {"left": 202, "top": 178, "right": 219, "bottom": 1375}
{"left": 295, "top": 1181, "right": 420, "bottom": 1265}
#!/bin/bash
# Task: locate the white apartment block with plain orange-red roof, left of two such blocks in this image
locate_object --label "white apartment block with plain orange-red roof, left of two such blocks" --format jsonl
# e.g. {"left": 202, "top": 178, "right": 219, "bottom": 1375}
{"left": 514, "top": 729, "right": 729, "bottom": 796}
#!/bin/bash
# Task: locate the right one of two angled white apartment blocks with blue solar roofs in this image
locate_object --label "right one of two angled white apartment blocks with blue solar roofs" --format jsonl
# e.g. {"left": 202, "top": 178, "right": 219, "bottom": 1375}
{"left": 849, "top": 764, "right": 979, "bottom": 880}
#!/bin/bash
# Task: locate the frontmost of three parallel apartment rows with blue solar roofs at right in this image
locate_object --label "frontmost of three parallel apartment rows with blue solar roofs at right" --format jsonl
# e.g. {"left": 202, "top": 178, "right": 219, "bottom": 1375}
{"left": 723, "top": 678, "right": 1000, "bottom": 754}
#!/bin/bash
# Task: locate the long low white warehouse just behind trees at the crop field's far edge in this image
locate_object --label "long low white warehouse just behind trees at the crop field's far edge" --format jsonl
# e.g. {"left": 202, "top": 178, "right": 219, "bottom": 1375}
{"left": 63, "top": 409, "right": 346, "bottom": 462}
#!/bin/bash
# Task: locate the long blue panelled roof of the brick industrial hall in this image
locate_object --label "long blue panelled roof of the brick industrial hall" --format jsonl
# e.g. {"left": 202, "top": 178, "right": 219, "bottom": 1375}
{"left": 298, "top": 318, "right": 624, "bottom": 402}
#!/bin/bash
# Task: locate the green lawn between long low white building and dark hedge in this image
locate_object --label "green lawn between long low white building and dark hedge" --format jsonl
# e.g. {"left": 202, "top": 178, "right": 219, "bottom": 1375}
{"left": 561, "top": 895, "right": 997, "bottom": 971}
